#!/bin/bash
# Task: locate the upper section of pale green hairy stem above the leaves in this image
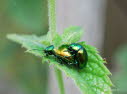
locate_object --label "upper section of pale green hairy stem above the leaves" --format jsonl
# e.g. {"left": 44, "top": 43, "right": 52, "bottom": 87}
{"left": 48, "top": 0, "right": 56, "bottom": 42}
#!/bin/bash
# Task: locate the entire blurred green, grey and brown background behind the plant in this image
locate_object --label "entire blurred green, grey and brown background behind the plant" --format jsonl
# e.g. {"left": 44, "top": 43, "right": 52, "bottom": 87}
{"left": 0, "top": 0, "right": 127, "bottom": 94}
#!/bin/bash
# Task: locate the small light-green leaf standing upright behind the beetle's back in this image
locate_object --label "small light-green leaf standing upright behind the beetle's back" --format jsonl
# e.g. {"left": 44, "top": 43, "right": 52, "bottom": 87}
{"left": 62, "top": 26, "right": 84, "bottom": 44}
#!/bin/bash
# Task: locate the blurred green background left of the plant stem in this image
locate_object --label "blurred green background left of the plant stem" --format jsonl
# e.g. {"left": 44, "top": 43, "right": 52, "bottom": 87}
{"left": 0, "top": 0, "right": 48, "bottom": 94}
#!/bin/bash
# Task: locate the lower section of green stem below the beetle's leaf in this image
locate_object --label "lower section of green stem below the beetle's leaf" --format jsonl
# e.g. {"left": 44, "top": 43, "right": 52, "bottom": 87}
{"left": 55, "top": 67, "right": 65, "bottom": 94}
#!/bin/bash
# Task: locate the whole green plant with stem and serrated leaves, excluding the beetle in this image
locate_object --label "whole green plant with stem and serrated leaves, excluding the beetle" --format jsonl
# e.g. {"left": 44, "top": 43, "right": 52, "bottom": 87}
{"left": 7, "top": 0, "right": 112, "bottom": 94}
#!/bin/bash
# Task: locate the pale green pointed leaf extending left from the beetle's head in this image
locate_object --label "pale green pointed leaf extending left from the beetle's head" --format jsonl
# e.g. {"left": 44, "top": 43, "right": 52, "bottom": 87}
{"left": 7, "top": 34, "right": 45, "bottom": 56}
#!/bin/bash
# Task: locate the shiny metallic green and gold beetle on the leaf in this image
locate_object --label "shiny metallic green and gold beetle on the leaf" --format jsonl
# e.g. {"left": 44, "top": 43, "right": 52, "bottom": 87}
{"left": 44, "top": 43, "right": 88, "bottom": 69}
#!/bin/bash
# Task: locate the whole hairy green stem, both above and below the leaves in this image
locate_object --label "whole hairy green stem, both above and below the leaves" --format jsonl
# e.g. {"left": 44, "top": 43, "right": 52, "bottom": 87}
{"left": 48, "top": 0, "right": 65, "bottom": 94}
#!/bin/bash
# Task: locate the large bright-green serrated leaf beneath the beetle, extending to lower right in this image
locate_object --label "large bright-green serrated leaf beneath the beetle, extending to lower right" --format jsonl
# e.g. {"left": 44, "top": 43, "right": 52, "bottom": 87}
{"left": 50, "top": 42, "right": 112, "bottom": 94}
